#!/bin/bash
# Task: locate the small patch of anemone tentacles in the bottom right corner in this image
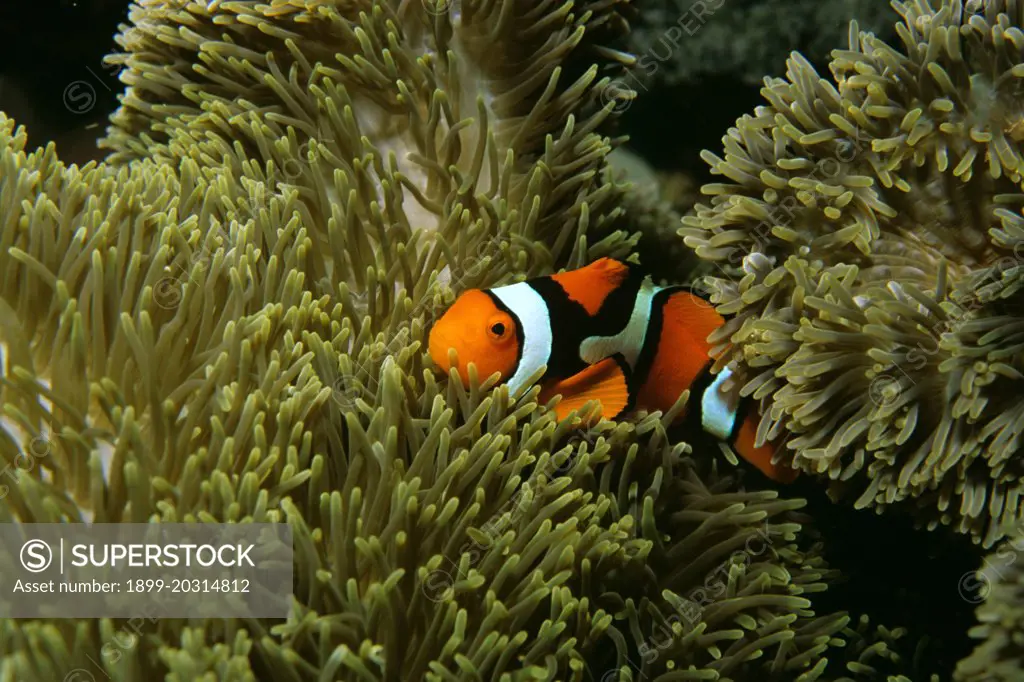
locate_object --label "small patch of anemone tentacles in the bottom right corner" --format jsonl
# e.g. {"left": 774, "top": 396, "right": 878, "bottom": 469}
{"left": 953, "top": 537, "right": 1024, "bottom": 682}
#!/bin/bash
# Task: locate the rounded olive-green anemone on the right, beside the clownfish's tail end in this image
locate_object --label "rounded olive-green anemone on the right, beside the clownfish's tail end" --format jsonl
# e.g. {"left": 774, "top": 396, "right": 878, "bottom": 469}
{"left": 681, "top": 0, "right": 1024, "bottom": 547}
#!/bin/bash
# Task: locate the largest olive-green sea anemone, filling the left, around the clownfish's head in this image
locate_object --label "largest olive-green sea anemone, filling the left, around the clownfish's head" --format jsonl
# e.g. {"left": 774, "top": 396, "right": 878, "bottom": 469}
{"left": 0, "top": 0, "right": 897, "bottom": 682}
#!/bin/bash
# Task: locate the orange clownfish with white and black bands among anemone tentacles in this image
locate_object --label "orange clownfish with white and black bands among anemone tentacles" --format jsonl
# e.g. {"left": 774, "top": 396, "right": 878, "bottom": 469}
{"left": 429, "top": 258, "right": 797, "bottom": 482}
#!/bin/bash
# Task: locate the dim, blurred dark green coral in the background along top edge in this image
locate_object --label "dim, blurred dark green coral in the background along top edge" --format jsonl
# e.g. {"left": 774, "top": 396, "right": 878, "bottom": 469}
{"left": 628, "top": 0, "right": 896, "bottom": 87}
